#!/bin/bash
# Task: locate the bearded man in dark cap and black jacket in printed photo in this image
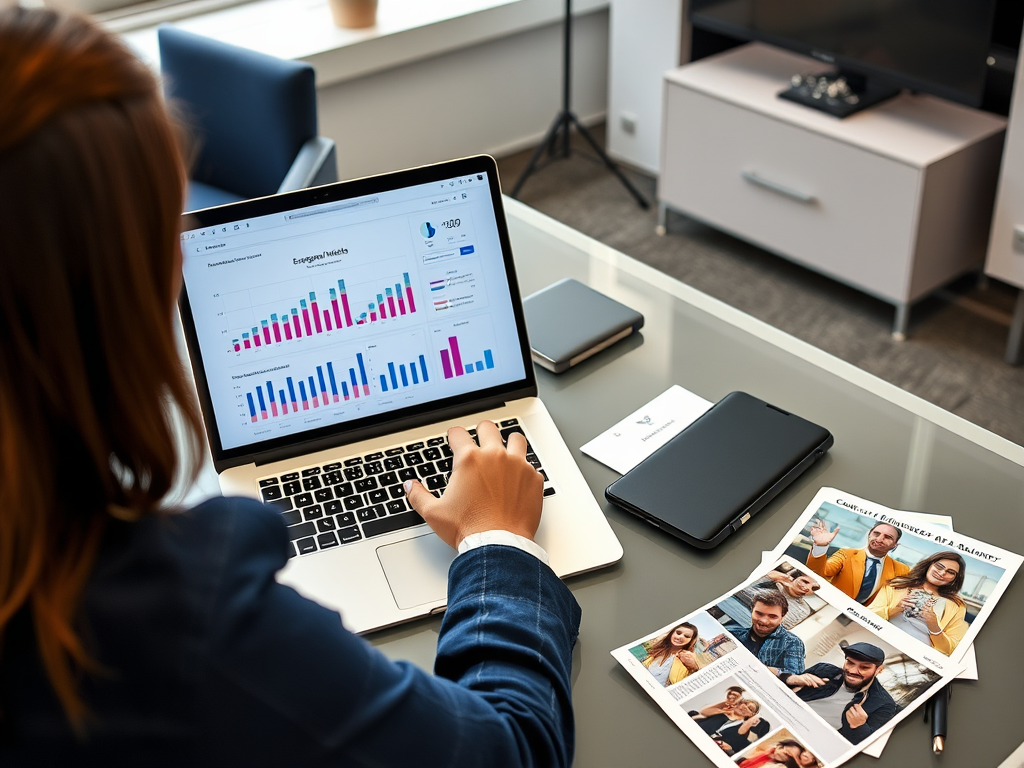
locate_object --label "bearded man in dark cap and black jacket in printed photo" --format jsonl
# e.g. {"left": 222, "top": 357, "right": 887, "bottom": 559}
{"left": 779, "top": 643, "right": 896, "bottom": 744}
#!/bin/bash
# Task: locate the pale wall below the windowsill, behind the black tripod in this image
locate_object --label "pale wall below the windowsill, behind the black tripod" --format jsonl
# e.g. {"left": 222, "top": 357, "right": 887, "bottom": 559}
{"left": 319, "top": 9, "right": 606, "bottom": 185}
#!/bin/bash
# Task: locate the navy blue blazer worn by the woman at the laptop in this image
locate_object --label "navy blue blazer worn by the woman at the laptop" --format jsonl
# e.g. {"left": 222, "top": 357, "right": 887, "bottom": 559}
{"left": 0, "top": 499, "right": 581, "bottom": 768}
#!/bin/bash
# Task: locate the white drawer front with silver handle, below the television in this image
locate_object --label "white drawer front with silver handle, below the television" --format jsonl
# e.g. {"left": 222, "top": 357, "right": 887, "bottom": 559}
{"left": 658, "top": 84, "right": 923, "bottom": 301}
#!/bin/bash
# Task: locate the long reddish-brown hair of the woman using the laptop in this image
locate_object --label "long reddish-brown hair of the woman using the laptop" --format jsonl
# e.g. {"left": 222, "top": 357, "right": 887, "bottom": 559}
{"left": 0, "top": 7, "right": 202, "bottom": 731}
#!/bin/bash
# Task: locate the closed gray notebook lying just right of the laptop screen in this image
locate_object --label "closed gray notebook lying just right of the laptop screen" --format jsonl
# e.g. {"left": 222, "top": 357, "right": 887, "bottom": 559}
{"left": 522, "top": 278, "right": 643, "bottom": 374}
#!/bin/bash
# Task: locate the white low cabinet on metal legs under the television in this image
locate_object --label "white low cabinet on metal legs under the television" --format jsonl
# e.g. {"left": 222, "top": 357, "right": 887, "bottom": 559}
{"left": 657, "top": 44, "right": 1006, "bottom": 336}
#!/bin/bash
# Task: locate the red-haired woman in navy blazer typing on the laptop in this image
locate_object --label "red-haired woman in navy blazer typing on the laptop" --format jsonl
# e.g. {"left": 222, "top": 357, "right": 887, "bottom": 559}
{"left": 0, "top": 7, "right": 580, "bottom": 766}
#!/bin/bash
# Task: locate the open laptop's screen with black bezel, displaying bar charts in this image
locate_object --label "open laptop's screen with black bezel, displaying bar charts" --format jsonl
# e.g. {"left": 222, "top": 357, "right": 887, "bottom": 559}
{"left": 181, "top": 159, "right": 528, "bottom": 466}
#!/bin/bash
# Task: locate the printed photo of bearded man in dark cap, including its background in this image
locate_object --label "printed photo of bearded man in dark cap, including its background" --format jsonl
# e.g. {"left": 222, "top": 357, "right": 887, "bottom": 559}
{"left": 778, "top": 607, "right": 940, "bottom": 743}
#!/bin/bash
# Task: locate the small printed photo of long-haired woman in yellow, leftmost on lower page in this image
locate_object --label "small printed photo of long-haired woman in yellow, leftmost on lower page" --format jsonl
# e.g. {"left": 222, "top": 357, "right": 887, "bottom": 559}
{"left": 630, "top": 611, "right": 736, "bottom": 687}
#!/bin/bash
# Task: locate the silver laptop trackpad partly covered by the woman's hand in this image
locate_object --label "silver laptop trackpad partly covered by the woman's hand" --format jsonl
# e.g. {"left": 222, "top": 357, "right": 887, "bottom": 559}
{"left": 377, "top": 534, "right": 458, "bottom": 608}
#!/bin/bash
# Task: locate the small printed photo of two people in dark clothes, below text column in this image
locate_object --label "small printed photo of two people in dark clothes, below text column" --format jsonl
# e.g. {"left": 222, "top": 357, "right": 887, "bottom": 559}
{"left": 682, "top": 677, "right": 779, "bottom": 757}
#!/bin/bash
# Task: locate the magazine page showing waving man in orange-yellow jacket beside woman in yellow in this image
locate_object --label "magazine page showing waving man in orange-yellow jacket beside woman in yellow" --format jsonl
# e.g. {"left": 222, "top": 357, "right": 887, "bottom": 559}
{"left": 772, "top": 487, "right": 1022, "bottom": 662}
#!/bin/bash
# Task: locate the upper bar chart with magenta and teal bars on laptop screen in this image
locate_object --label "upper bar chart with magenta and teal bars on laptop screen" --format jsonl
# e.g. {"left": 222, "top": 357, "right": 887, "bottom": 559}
{"left": 220, "top": 268, "right": 421, "bottom": 355}
